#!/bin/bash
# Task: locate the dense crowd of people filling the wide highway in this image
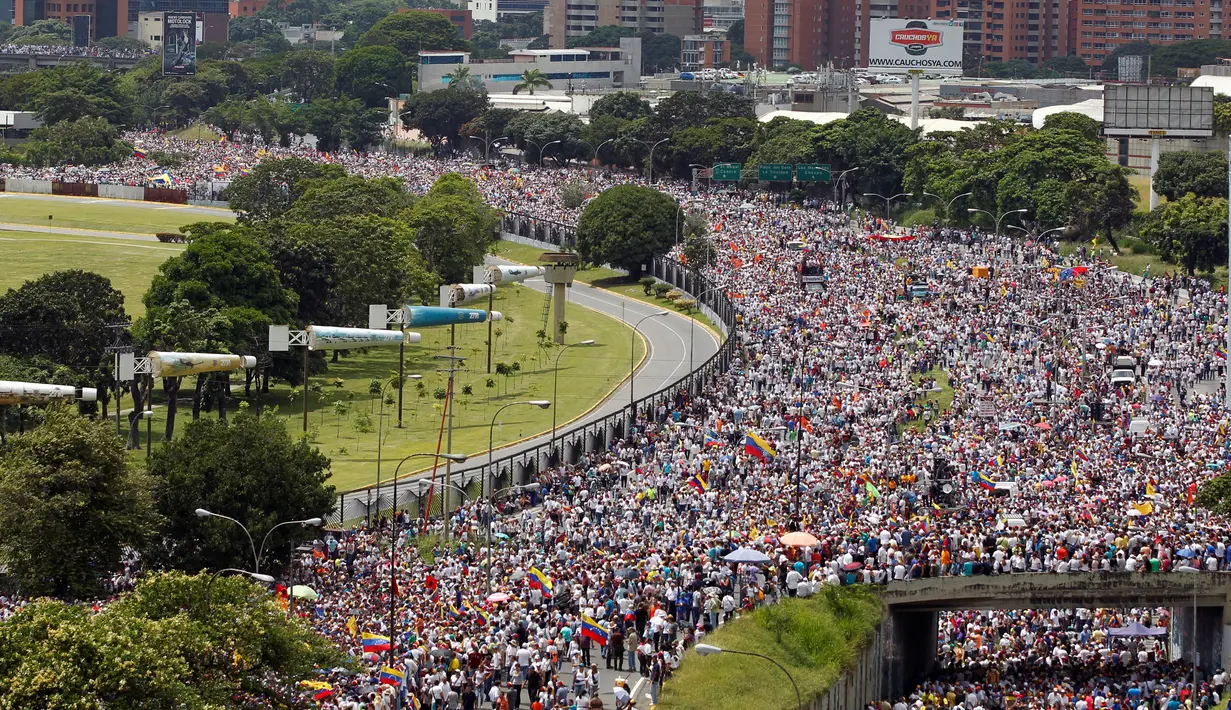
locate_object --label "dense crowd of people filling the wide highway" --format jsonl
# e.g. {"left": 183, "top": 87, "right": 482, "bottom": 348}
{"left": 7, "top": 124, "right": 1231, "bottom": 710}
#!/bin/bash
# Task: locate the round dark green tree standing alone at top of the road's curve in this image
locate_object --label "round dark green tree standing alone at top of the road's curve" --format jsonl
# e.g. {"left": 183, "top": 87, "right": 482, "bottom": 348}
{"left": 577, "top": 185, "right": 678, "bottom": 277}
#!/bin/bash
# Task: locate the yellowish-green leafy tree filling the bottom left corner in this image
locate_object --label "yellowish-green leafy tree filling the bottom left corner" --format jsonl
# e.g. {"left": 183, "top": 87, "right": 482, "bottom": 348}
{"left": 0, "top": 573, "right": 341, "bottom": 710}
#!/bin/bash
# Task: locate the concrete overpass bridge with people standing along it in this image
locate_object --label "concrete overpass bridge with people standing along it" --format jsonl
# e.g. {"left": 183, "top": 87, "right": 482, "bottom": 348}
{"left": 880, "top": 572, "right": 1231, "bottom": 696}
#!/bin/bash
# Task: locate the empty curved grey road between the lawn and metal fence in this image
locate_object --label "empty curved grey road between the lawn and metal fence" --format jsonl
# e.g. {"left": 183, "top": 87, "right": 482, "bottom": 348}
{"left": 339, "top": 256, "right": 720, "bottom": 521}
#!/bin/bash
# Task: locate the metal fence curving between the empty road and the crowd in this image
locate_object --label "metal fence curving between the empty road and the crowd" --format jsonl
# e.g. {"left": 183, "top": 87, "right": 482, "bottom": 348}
{"left": 330, "top": 214, "right": 736, "bottom": 524}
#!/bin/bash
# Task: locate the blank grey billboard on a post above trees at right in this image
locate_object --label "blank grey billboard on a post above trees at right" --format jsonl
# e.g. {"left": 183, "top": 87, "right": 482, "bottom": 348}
{"left": 1103, "top": 85, "right": 1214, "bottom": 138}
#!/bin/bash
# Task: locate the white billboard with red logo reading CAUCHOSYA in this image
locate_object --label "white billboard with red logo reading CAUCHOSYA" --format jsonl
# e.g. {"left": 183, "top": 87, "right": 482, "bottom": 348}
{"left": 868, "top": 18, "right": 964, "bottom": 76}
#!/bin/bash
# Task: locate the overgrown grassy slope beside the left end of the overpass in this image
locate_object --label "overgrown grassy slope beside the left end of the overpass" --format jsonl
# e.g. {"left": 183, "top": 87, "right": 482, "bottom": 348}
{"left": 656, "top": 586, "right": 881, "bottom": 710}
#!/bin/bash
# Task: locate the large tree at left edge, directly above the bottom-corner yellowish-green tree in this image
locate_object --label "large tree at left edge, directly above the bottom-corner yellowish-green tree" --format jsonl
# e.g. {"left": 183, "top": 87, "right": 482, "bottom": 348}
{"left": 0, "top": 407, "right": 158, "bottom": 598}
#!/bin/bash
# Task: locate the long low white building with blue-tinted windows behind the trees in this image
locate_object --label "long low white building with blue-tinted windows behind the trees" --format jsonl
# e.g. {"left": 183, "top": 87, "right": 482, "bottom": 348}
{"left": 419, "top": 37, "right": 641, "bottom": 94}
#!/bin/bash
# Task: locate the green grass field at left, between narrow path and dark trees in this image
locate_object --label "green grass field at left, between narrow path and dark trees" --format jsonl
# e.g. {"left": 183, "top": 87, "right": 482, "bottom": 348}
{"left": 0, "top": 230, "right": 183, "bottom": 317}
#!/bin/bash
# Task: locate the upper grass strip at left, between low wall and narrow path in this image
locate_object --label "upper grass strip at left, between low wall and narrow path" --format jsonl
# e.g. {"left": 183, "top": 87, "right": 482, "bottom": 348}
{"left": 0, "top": 196, "right": 235, "bottom": 234}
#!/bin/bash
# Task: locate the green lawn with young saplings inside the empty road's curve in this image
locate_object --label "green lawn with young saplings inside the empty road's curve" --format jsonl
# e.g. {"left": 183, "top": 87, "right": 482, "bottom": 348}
{"left": 123, "top": 279, "right": 645, "bottom": 491}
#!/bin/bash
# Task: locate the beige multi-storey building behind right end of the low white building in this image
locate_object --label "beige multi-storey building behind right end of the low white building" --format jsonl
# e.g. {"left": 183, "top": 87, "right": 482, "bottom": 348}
{"left": 543, "top": 0, "right": 704, "bottom": 49}
